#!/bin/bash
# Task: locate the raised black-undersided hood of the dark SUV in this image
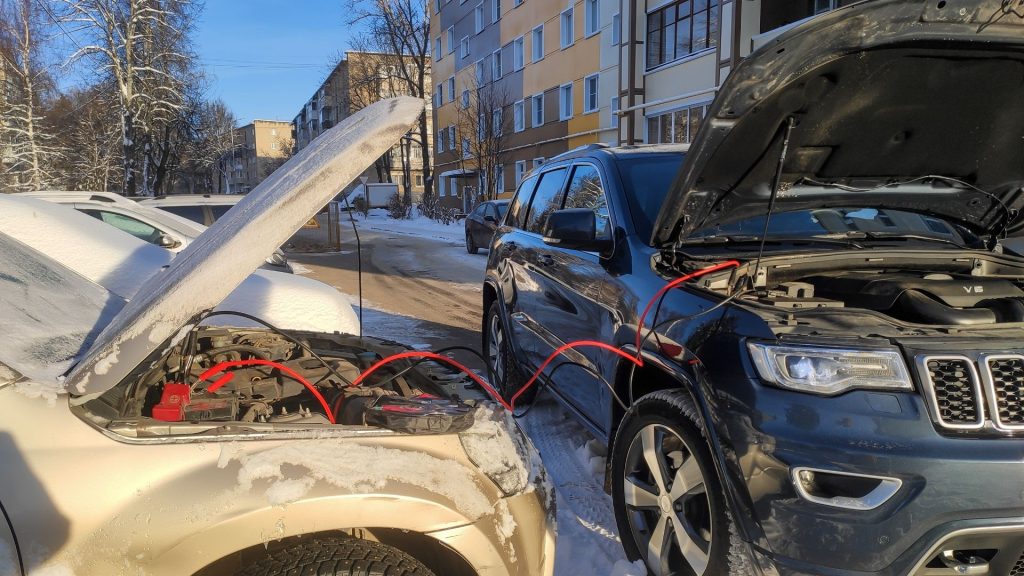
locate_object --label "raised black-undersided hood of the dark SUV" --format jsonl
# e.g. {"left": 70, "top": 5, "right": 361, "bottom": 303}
{"left": 652, "top": 0, "right": 1024, "bottom": 245}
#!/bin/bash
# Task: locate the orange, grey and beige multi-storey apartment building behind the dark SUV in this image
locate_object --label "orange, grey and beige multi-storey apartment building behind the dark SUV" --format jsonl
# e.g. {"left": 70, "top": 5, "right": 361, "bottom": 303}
{"left": 431, "top": 0, "right": 853, "bottom": 209}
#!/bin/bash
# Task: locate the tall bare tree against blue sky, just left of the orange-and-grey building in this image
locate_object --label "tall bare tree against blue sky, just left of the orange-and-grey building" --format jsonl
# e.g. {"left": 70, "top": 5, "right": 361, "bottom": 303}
{"left": 345, "top": 0, "right": 433, "bottom": 196}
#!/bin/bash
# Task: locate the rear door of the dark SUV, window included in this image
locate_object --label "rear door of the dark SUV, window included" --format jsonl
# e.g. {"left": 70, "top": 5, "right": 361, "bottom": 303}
{"left": 513, "top": 166, "right": 568, "bottom": 366}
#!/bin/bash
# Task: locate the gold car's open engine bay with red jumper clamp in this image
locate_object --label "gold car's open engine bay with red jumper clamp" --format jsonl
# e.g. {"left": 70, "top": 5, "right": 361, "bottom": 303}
{"left": 100, "top": 327, "right": 473, "bottom": 434}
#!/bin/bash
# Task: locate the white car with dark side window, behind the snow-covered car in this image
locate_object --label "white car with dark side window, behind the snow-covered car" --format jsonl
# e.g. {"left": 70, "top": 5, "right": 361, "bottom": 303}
{"left": 22, "top": 191, "right": 293, "bottom": 274}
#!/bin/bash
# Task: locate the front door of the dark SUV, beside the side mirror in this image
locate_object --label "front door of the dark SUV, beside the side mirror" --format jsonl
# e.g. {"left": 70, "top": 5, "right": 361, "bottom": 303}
{"left": 516, "top": 163, "right": 624, "bottom": 429}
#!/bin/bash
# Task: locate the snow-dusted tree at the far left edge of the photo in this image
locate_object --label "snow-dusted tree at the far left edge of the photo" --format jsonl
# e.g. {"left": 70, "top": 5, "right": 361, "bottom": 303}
{"left": 0, "top": 0, "right": 60, "bottom": 190}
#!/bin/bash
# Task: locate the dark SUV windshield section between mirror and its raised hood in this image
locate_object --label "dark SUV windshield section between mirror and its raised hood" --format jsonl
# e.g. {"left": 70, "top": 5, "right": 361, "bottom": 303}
{"left": 618, "top": 153, "right": 683, "bottom": 241}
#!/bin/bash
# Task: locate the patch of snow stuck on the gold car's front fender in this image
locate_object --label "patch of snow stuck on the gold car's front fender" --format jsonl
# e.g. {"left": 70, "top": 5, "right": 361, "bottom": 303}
{"left": 218, "top": 439, "right": 493, "bottom": 521}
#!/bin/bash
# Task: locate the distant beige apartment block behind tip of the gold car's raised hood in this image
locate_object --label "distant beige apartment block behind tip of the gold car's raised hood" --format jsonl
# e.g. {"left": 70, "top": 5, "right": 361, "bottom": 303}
{"left": 292, "top": 51, "right": 433, "bottom": 202}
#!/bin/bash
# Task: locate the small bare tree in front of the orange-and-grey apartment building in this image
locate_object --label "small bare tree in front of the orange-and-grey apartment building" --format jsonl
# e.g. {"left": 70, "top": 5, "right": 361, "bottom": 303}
{"left": 453, "top": 81, "right": 516, "bottom": 203}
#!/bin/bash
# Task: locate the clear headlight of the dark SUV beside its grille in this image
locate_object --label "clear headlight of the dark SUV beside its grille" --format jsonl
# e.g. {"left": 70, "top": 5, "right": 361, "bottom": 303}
{"left": 746, "top": 342, "right": 912, "bottom": 396}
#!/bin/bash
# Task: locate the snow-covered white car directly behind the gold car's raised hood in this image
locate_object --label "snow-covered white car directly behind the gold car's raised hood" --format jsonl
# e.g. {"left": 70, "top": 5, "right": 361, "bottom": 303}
{"left": 0, "top": 194, "right": 359, "bottom": 334}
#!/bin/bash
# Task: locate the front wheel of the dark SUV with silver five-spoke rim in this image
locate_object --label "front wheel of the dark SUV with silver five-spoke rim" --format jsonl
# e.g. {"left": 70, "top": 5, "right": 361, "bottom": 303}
{"left": 611, "top": 390, "right": 746, "bottom": 576}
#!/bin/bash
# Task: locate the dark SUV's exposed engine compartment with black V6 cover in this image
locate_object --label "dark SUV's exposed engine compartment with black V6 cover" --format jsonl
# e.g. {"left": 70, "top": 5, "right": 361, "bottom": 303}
{"left": 753, "top": 270, "right": 1024, "bottom": 326}
